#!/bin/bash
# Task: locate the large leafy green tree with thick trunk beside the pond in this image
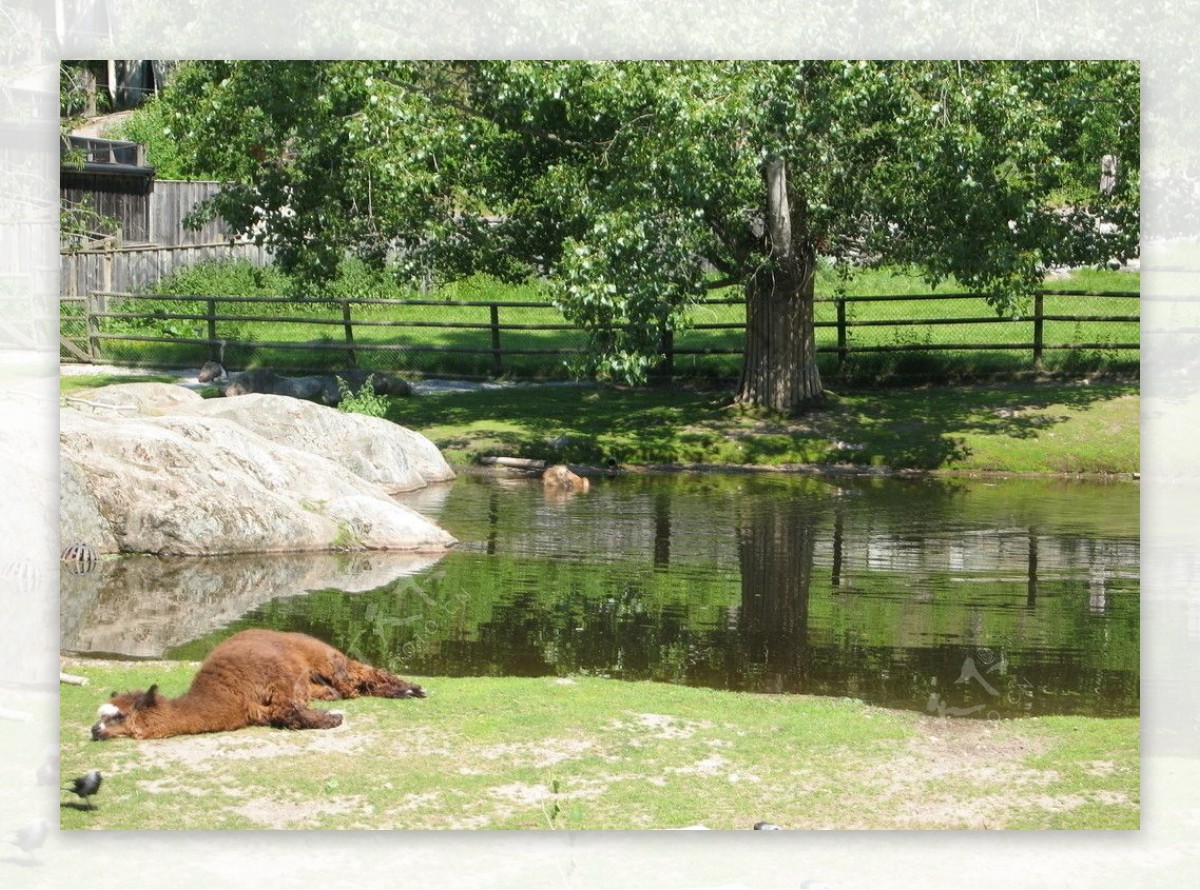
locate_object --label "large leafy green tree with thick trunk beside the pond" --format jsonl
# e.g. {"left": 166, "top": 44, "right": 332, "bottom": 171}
{"left": 150, "top": 61, "right": 1139, "bottom": 410}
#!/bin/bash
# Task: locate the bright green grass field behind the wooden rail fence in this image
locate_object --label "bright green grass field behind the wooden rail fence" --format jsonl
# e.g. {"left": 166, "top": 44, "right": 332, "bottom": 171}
{"left": 64, "top": 263, "right": 1140, "bottom": 385}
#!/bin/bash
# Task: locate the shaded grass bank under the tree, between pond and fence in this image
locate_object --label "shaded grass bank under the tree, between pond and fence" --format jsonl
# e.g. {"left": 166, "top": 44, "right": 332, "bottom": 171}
{"left": 388, "top": 383, "right": 1140, "bottom": 474}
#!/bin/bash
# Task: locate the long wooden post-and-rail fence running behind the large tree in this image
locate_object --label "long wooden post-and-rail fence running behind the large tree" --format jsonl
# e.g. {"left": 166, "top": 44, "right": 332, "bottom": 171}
{"left": 61, "top": 289, "right": 1140, "bottom": 377}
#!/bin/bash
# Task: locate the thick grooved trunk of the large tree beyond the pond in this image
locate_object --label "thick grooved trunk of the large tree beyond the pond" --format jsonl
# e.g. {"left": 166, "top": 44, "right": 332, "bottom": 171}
{"left": 737, "top": 158, "right": 822, "bottom": 411}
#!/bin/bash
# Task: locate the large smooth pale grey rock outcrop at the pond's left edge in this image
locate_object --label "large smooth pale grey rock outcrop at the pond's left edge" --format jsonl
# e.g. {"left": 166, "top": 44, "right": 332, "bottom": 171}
{"left": 59, "top": 384, "right": 454, "bottom": 555}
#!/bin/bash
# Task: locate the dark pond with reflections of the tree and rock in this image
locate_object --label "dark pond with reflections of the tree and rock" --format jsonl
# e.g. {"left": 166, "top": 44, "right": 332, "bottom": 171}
{"left": 62, "top": 474, "right": 1140, "bottom": 717}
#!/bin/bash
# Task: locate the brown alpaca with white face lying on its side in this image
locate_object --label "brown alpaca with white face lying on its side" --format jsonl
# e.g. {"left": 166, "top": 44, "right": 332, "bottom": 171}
{"left": 91, "top": 630, "right": 425, "bottom": 741}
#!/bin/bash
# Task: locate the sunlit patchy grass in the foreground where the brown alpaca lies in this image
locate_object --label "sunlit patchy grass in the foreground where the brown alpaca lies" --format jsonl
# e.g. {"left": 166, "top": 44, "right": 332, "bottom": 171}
{"left": 61, "top": 661, "right": 1140, "bottom": 830}
